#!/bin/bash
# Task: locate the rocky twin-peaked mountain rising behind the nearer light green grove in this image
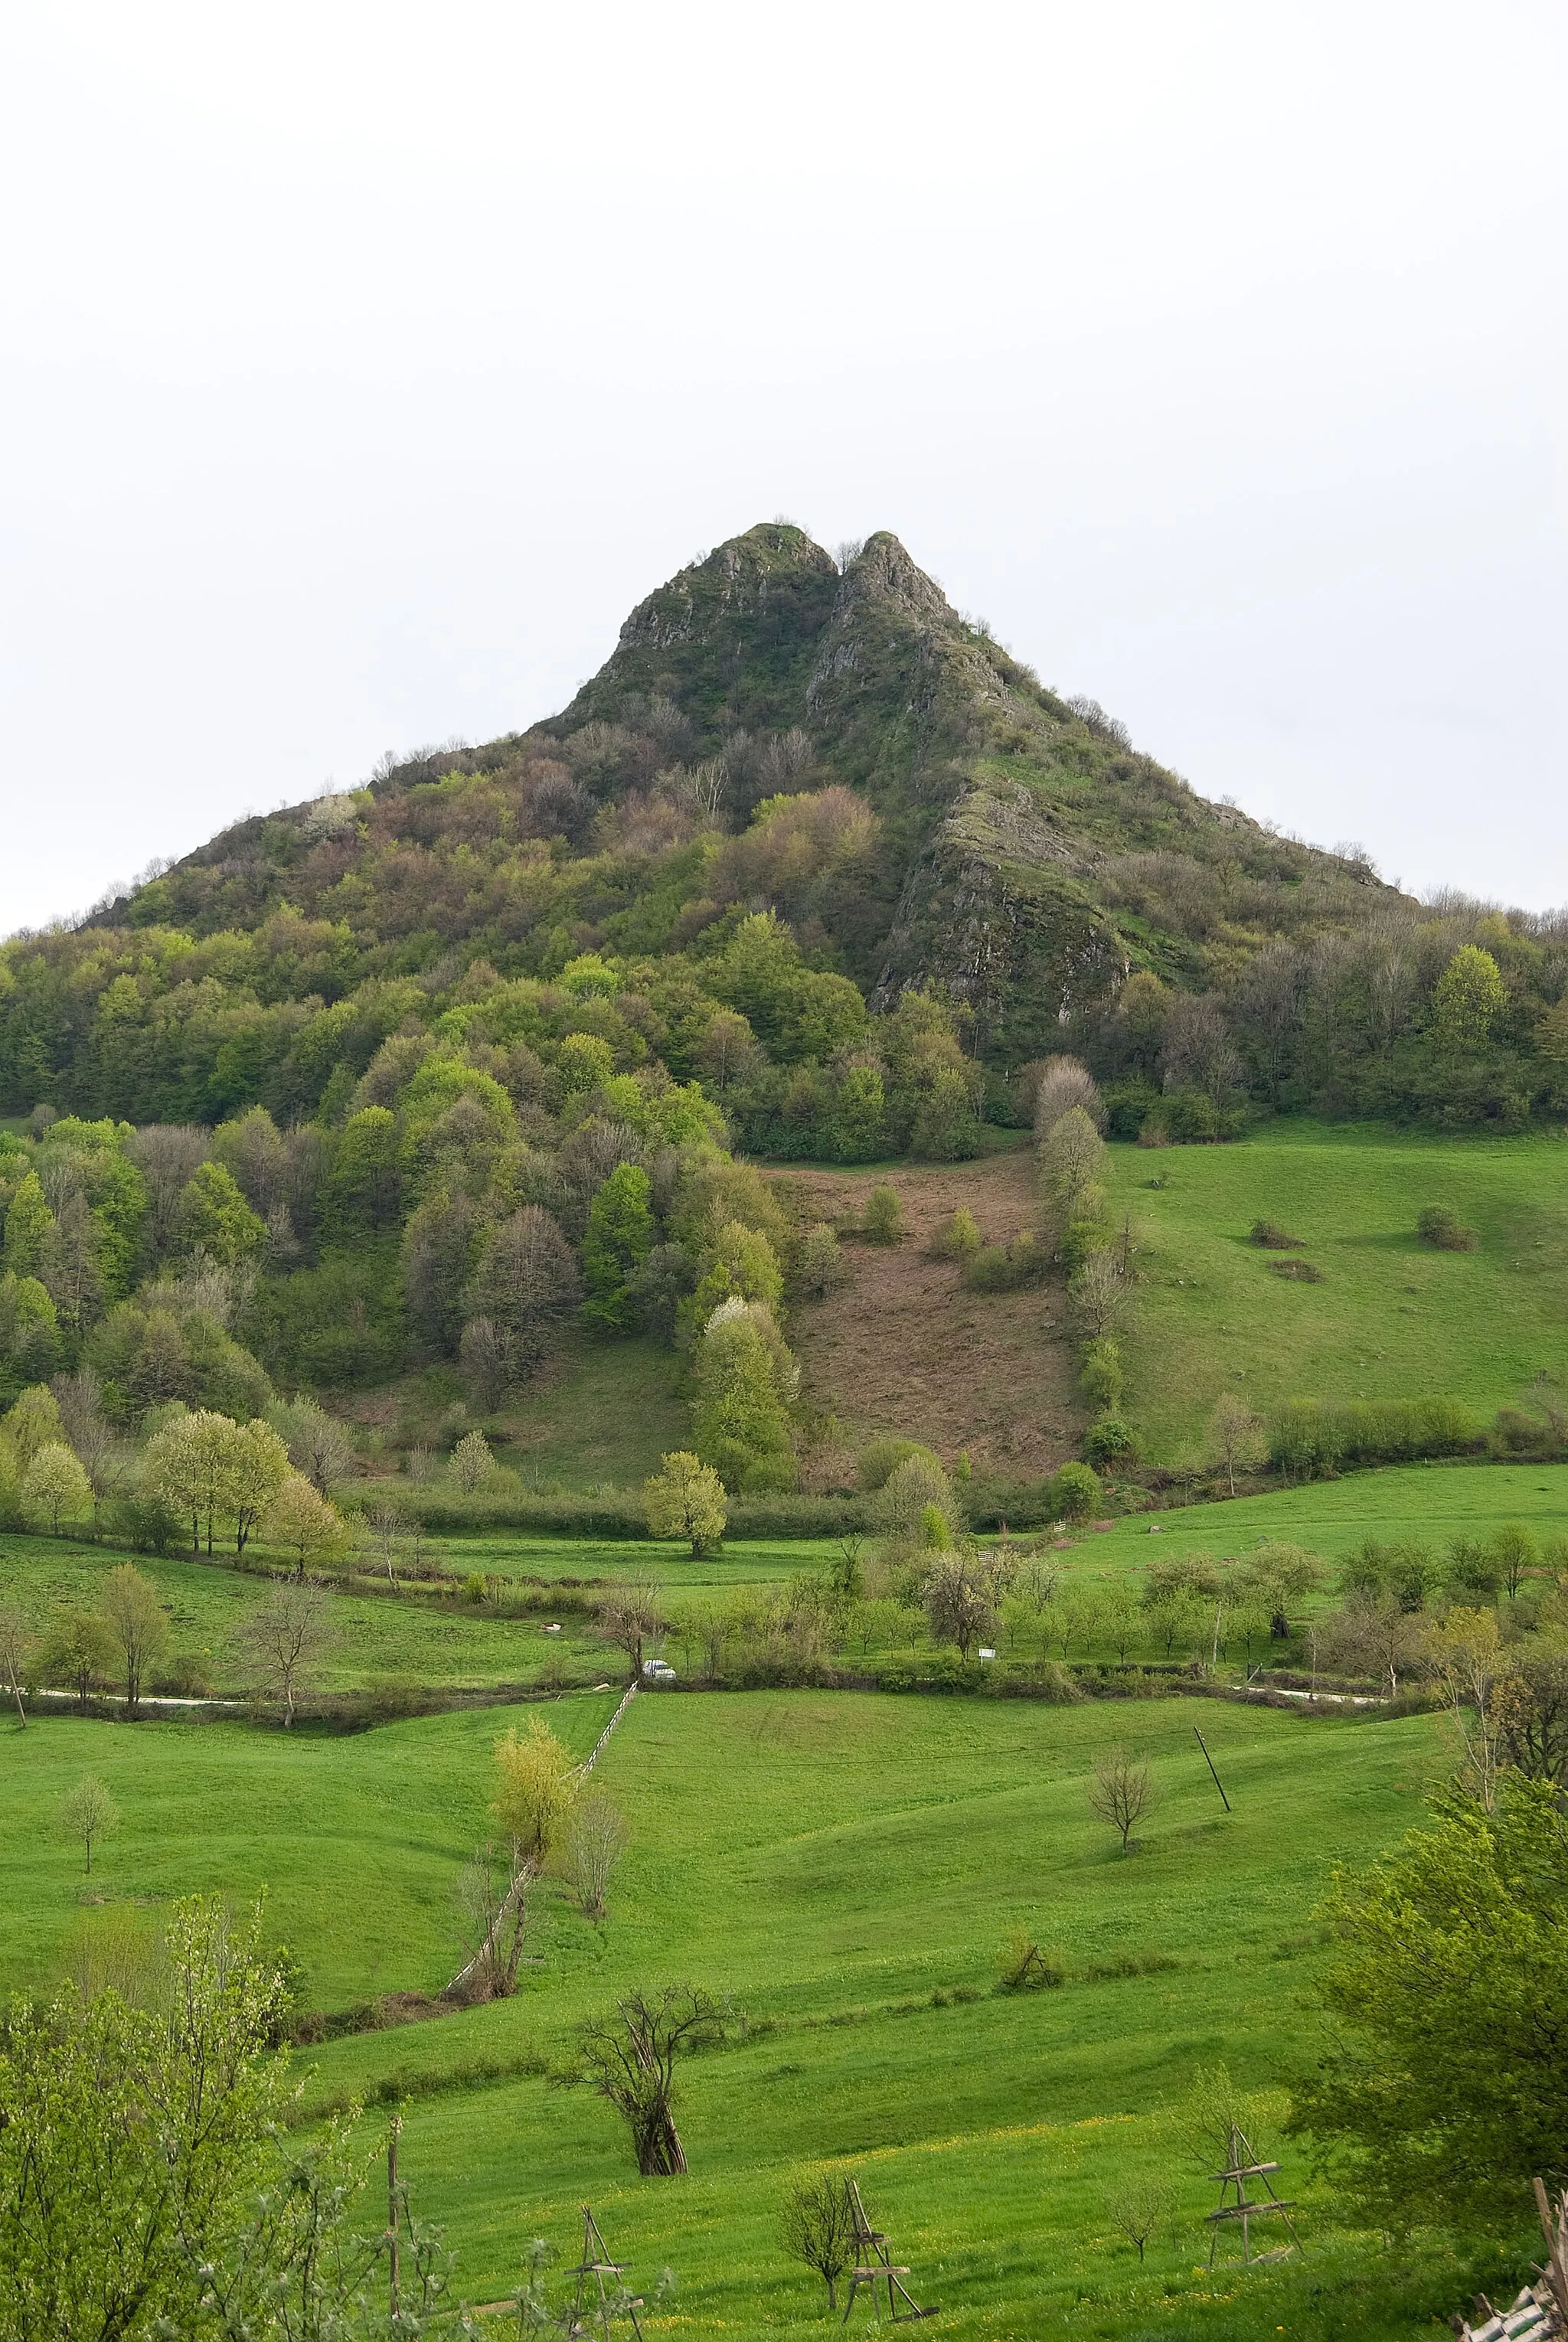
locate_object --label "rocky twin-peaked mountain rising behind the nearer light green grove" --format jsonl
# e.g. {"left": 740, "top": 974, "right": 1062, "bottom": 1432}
{"left": 0, "top": 522, "right": 1568, "bottom": 1157}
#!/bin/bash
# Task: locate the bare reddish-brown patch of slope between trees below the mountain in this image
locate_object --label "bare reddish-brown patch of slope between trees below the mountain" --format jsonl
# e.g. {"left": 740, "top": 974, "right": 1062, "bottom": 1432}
{"left": 763, "top": 1150, "right": 1085, "bottom": 1480}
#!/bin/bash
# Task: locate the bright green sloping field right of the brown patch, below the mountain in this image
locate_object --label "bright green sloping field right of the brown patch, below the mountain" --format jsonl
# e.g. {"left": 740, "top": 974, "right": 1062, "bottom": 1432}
{"left": 1111, "top": 1119, "right": 1568, "bottom": 1464}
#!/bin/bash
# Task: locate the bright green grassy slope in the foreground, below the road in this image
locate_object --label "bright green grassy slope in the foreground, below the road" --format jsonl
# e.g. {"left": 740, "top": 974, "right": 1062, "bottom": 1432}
{"left": 0, "top": 1694, "right": 1490, "bottom": 2337}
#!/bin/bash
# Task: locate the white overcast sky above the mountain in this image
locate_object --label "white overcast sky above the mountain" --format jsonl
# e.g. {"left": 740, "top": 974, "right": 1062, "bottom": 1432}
{"left": 0, "top": 0, "right": 1568, "bottom": 932}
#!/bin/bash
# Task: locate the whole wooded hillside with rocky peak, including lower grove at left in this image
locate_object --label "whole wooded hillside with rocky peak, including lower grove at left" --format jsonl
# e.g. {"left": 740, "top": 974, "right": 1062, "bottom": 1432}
{"left": 0, "top": 524, "right": 1568, "bottom": 1490}
